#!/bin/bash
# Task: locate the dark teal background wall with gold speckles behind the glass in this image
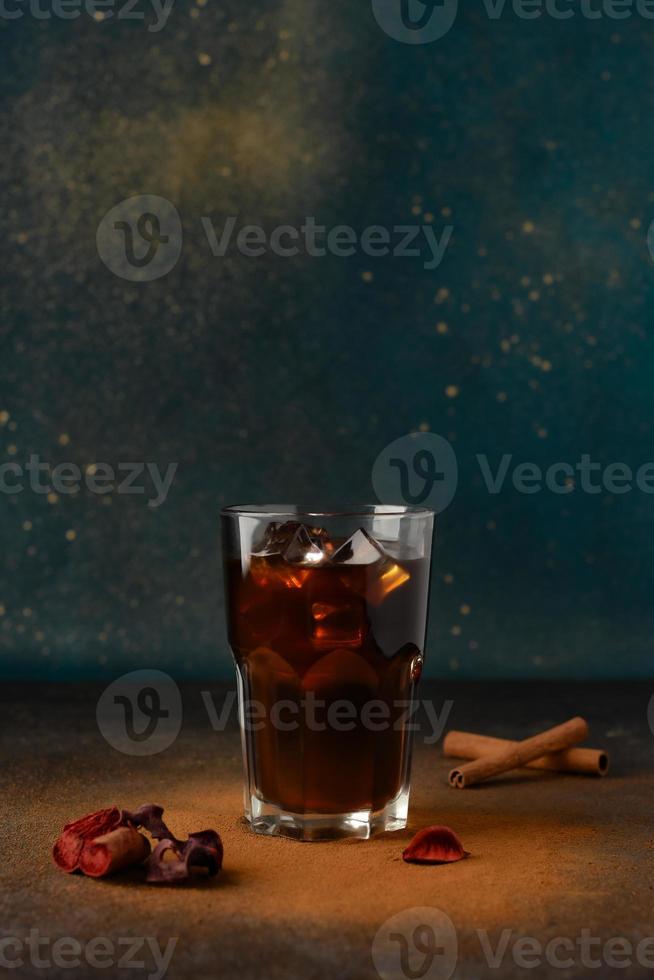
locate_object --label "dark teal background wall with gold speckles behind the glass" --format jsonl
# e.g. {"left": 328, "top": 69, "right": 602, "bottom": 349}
{"left": 0, "top": 0, "right": 654, "bottom": 678}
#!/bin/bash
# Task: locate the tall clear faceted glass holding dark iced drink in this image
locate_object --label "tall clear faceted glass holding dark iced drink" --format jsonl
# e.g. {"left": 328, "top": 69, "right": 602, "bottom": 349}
{"left": 222, "top": 505, "right": 434, "bottom": 840}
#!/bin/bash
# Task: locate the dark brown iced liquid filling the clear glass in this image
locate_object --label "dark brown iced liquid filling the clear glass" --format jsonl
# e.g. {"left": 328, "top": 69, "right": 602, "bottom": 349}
{"left": 227, "top": 555, "right": 429, "bottom": 813}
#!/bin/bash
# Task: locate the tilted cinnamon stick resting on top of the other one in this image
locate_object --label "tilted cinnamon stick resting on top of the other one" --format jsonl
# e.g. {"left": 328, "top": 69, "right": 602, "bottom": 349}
{"left": 449, "top": 718, "right": 588, "bottom": 789}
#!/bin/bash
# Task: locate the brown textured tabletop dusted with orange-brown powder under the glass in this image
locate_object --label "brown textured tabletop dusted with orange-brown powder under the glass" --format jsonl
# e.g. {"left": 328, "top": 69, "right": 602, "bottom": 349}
{"left": 0, "top": 683, "right": 654, "bottom": 980}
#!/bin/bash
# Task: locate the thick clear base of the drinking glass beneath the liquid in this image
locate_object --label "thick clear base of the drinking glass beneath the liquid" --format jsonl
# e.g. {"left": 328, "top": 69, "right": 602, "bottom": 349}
{"left": 245, "top": 789, "right": 409, "bottom": 841}
